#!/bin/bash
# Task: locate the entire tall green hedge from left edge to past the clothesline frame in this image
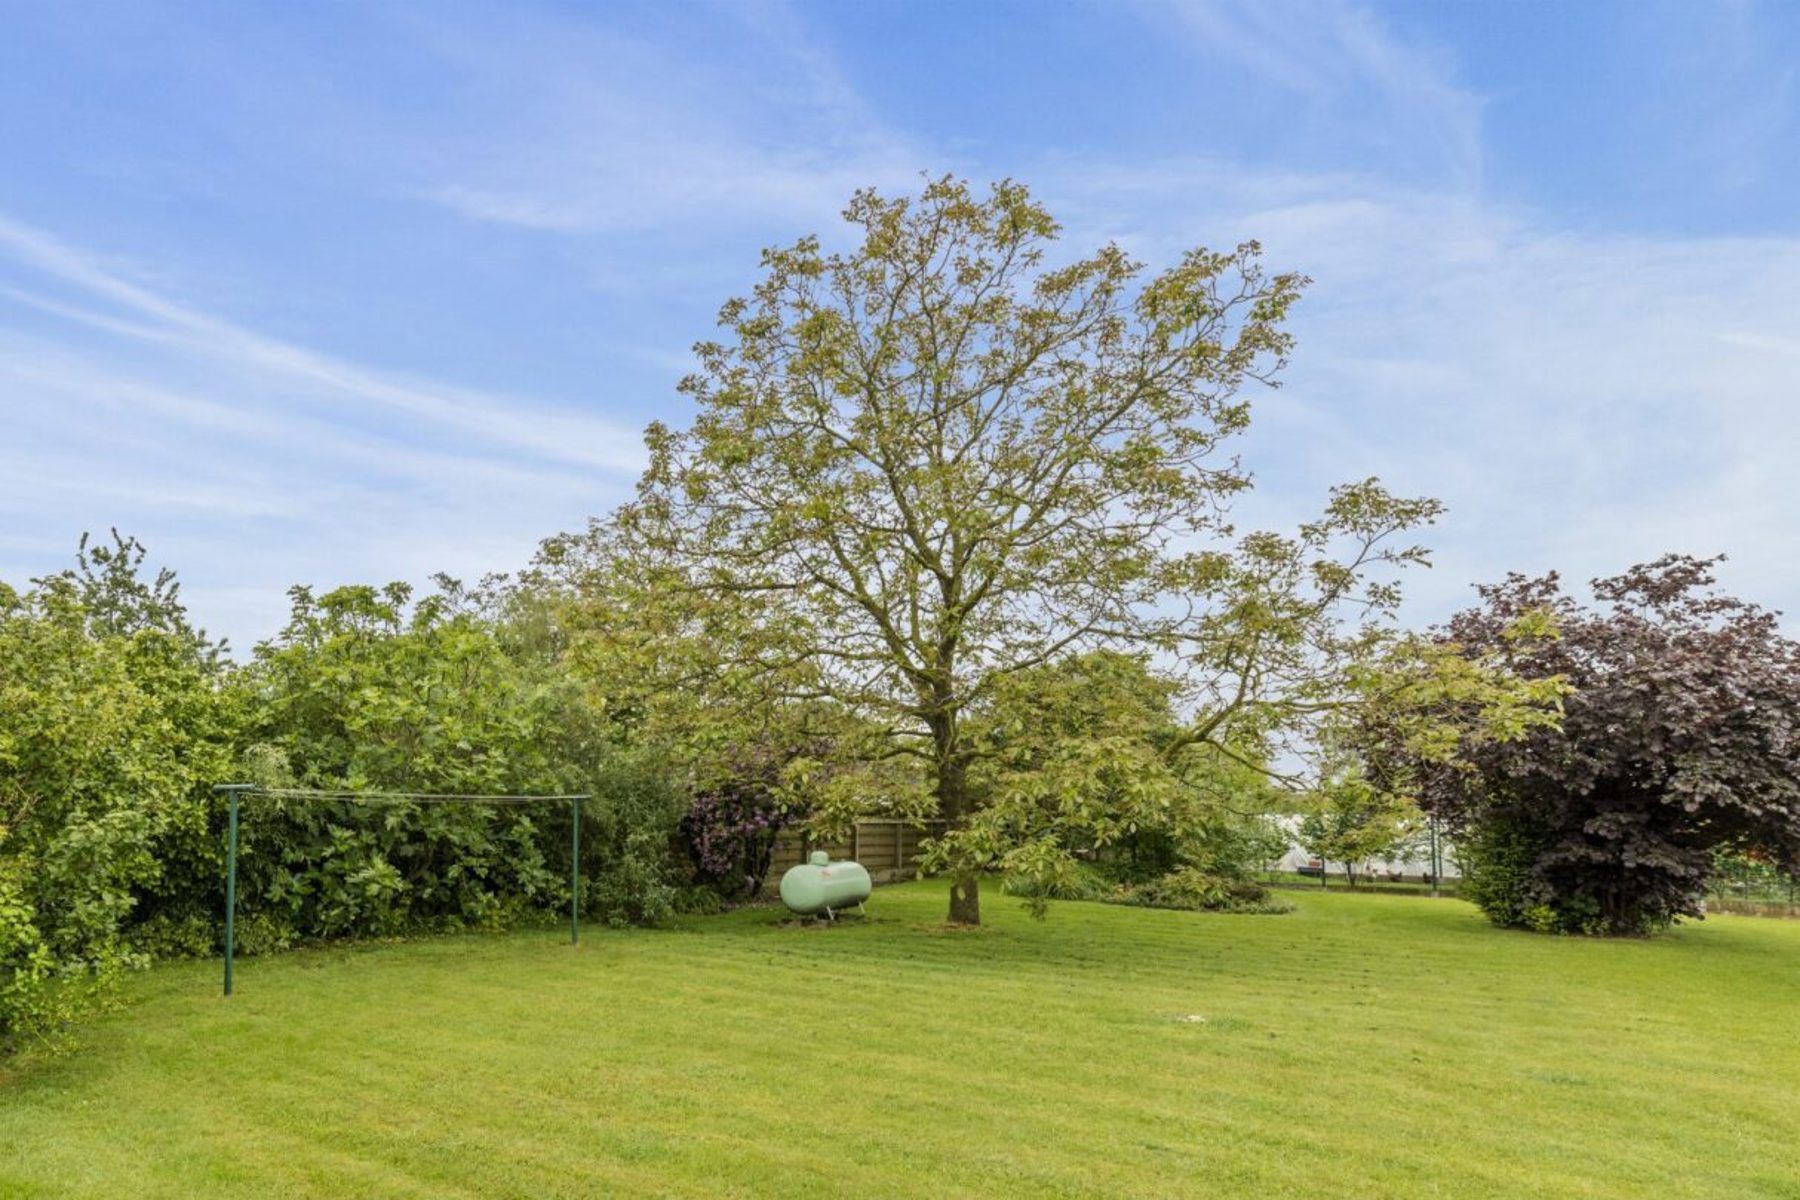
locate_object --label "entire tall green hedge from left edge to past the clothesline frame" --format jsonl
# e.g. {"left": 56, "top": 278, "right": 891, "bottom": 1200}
{"left": 0, "top": 534, "right": 688, "bottom": 1049}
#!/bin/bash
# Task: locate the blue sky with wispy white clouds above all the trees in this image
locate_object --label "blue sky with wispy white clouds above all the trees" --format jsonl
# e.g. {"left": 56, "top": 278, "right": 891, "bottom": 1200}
{"left": 0, "top": 0, "right": 1800, "bottom": 646}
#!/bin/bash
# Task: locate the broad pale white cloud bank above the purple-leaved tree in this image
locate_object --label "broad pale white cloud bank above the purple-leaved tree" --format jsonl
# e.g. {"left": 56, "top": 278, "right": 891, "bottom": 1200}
{"left": 1046, "top": 162, "right": 1800, "bottom": 617}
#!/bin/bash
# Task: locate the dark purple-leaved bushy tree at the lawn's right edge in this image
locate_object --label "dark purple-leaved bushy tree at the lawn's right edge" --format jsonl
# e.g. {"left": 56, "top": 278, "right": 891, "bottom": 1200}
{"left": 1375, "top": 554, "right": 1800, "bottom": 934}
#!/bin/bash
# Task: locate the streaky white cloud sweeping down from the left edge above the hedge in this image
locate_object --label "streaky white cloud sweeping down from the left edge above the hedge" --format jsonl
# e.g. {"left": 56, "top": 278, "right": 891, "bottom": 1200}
{"left": 0, "top": 219, "right": 643, "bottom": 644}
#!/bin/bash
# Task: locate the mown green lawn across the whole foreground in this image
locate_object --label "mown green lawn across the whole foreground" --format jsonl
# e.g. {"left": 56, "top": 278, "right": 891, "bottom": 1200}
{"left": 0, "top": 883, "right": 1800, "bottom": 1200}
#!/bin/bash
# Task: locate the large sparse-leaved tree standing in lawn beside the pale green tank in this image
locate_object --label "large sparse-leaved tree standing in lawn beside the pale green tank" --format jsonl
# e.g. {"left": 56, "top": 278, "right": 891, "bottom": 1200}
{"left": 608, "top": 178, "right": 1436, "bottom": 923}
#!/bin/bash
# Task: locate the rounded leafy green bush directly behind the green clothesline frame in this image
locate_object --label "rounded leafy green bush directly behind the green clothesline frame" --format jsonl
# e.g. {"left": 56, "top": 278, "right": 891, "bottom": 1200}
{"left": 239, "top": 581, "right": 694, "bottom": 943}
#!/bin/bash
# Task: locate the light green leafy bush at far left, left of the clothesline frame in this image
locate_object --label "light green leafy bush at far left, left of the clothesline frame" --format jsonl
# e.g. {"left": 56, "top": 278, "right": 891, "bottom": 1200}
{"left": 0, "top": 536, "right": 234, "bottom": 1045}
